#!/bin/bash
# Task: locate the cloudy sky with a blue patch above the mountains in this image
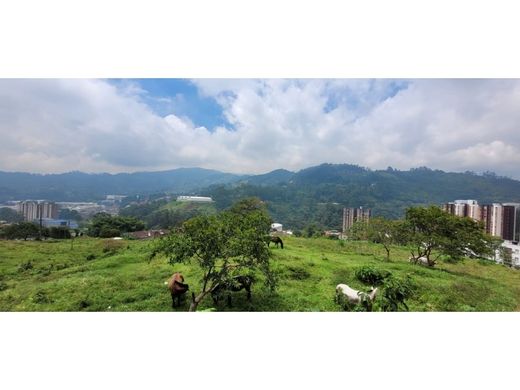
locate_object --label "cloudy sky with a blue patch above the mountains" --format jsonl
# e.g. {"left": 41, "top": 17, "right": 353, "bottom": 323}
{"left": 0, "top": 79, "right": 520, "bottom": 179}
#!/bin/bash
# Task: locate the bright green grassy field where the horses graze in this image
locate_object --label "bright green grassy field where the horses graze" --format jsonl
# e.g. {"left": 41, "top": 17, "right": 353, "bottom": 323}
{"left": 0, "top": 238, "right": 520, "bottom": 311}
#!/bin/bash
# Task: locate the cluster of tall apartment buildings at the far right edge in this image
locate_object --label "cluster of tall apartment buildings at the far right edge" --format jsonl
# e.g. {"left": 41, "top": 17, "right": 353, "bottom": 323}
{"left": 443, "top": 199, "right": 520, "bottom": 267}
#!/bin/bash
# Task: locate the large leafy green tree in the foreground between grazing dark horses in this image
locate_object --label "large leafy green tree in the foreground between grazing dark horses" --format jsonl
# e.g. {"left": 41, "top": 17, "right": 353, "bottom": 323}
{"left": 152, "top": 199, "right": 275, "bottom": 311}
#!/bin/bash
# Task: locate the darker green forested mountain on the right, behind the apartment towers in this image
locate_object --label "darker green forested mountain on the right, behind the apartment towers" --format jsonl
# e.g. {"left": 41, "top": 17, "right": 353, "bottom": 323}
{"left": 206, "top": 164, "right": 520, "bottom": 229}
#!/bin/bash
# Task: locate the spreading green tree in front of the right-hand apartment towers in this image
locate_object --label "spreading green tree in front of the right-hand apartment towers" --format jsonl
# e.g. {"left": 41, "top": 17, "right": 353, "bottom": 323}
{"left": 402, "top": 206, "right": 494, "bottom": 266}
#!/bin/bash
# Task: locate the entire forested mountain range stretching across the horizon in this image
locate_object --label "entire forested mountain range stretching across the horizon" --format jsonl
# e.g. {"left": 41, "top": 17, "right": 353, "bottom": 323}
{"left": 0, "top": 164, "right": 520, "bottom": 228}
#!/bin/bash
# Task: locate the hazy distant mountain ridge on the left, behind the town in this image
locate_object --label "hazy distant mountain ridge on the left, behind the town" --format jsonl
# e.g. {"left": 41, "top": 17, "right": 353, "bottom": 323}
{"left": 0, "top": 168, "right": 241, "bottom": 202}
